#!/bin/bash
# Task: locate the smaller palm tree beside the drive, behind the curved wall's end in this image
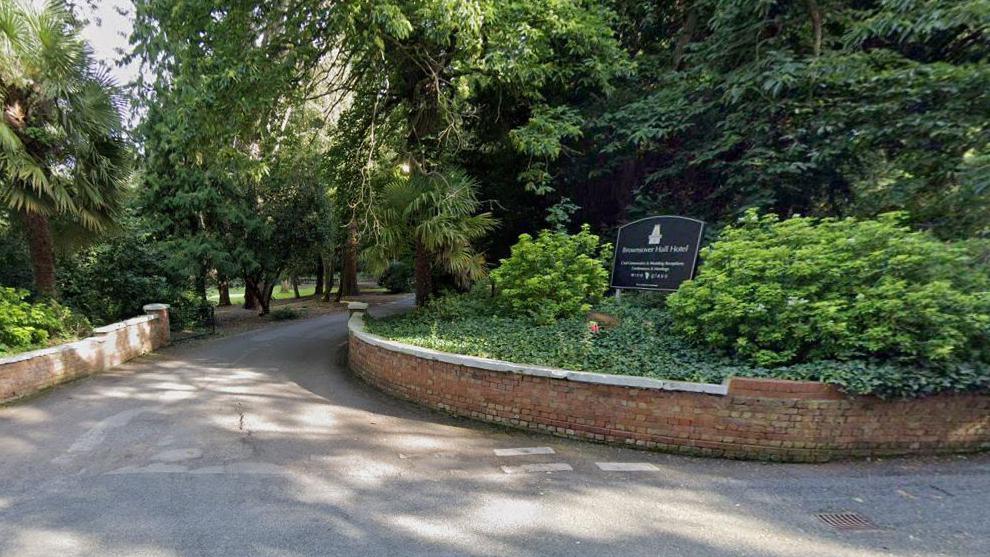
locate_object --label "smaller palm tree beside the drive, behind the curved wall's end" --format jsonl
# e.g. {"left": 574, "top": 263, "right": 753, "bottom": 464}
{"left": 364, "top": 170, "right": 496, "bottom": 306}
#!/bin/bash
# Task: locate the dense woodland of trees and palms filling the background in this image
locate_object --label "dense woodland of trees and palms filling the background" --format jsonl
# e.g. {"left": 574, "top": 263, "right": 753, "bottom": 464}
{"left": 0, "top": 0, "right": 990, "bottom": 322}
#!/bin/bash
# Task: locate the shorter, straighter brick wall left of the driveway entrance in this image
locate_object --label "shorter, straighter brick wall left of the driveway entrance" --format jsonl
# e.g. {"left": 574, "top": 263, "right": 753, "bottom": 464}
{"left": 0, "top": 304, "right": 170, "bottom": 403}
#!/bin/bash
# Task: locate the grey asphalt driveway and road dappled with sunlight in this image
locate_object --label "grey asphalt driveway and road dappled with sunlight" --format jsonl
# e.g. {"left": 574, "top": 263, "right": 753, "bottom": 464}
{"left": 0, "top": 301, "right": 990, "bottom": 557}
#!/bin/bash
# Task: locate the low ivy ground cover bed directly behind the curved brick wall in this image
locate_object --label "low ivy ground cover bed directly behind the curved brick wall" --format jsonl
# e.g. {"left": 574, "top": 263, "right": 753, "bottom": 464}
{"left": 368, "top": 294, "right": 990, "bottom": 397}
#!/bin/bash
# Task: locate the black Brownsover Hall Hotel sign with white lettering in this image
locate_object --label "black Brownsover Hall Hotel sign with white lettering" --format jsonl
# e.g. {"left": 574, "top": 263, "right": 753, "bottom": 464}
{"left": 612, "top": 216, "right": 705, "bottom": 290}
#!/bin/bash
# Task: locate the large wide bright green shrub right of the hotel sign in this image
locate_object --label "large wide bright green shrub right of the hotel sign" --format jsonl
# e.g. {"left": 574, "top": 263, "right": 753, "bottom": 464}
{"left": 668, "top": 212, "right": 990, "bottom": 368}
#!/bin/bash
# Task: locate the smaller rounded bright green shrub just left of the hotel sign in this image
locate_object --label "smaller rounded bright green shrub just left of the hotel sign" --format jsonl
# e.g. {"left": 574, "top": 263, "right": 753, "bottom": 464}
{"left": 492, "top": 225, "right": 611, "bottom": 323}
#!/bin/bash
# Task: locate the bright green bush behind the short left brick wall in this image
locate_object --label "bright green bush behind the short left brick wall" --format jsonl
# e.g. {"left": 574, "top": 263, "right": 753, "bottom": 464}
{"left": 0, "top": 287, "right": 90, "bottom": 356}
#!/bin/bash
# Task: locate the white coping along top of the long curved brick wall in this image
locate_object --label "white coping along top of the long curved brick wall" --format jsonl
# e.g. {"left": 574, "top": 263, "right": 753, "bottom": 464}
{"left": 347, "top": 311, "right": 729, "bottom": 396}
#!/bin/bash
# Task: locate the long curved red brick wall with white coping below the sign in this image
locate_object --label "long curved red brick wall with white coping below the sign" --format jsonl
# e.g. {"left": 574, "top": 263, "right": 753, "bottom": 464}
{"left": 348, "top": 312, "right": 990, "bottom": 462}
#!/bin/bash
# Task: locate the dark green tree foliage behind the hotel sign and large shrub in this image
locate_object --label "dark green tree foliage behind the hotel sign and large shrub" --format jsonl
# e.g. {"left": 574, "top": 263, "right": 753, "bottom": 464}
{"left": 560, "top": 0, "right": 990, "bottom": 238}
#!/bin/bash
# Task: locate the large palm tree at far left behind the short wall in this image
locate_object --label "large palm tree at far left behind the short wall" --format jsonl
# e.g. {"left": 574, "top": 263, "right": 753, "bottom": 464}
{"left": 0, "top": 0, "right": 129, "bottom": 296}
